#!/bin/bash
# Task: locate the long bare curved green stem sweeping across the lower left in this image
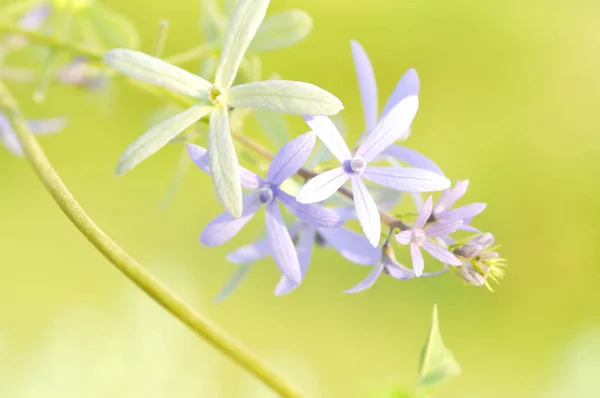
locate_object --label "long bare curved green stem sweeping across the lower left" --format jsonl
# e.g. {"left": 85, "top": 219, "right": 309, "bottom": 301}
{"left": 0, "top": 81, "right": 303, "bottom": 397}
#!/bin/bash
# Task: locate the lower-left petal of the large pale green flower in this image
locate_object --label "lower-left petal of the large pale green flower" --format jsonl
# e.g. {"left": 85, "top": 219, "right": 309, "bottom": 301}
{"left": 116, "top": 105, "right": 213, "bottom": 176}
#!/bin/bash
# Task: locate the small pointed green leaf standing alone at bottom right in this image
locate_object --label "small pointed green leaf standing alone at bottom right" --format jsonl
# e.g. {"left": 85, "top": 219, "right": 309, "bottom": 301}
{"left": 419, "top": 306, "right": 461, "bottom": 391}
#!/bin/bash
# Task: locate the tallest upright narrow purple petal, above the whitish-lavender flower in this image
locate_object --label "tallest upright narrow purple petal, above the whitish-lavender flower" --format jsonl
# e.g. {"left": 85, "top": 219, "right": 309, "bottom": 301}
{"left": 350, "top": 40, "right": 379, "bottom": 131}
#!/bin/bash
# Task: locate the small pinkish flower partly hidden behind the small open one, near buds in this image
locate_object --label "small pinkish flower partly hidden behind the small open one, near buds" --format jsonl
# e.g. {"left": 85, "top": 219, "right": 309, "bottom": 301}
{"left": 433, "top": 180, "right": 486, "bottom": 232}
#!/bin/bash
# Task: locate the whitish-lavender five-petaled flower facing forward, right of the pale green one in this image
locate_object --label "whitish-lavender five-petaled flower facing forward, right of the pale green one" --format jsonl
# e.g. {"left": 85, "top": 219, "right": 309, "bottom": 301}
{"left": 297, "top": 95, "right": 450, "bottom": 246}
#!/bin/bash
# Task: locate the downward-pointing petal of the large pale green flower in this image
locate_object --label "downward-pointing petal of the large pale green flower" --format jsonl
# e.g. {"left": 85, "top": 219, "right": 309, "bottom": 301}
{"left": 208, "top": 106, "right": 242, "bottom": 217}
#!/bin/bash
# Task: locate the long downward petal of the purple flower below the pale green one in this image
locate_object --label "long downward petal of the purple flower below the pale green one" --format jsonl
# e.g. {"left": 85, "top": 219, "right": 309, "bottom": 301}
{"left": 265, "top": 200, "right": 302, "bottom": 283}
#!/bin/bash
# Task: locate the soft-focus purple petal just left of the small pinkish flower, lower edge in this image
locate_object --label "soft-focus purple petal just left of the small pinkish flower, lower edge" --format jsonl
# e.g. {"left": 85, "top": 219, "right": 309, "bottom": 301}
{"left": 319, "top": 228, "right": 381, "bottom": 265}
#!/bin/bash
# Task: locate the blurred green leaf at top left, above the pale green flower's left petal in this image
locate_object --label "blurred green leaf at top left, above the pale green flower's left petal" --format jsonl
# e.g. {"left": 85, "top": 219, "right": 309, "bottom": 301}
{"left": 82, "top": 2, "right": 140, "bottom": 49}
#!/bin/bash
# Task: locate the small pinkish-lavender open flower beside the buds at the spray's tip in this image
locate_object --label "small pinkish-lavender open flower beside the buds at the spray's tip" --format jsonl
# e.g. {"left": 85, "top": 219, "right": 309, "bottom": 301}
{"left": 396, "top": 196, "right": 462, "bottom": 276}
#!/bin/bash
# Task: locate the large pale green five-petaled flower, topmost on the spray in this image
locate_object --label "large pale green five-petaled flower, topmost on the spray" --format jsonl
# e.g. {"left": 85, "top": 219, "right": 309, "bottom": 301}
{"left": 104, "top": 0, "right": 343, "bottom": 217}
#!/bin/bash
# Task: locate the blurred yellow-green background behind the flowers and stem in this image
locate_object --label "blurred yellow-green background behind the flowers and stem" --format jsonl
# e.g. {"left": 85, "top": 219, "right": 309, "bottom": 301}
{"left": 0, "top": 0, "right": 600, "bottom": 398}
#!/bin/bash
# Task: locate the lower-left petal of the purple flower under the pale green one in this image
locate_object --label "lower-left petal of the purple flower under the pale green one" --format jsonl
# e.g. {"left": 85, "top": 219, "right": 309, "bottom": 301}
{"left": 200, "top": 194, "right": 261, "bottom": 246}
